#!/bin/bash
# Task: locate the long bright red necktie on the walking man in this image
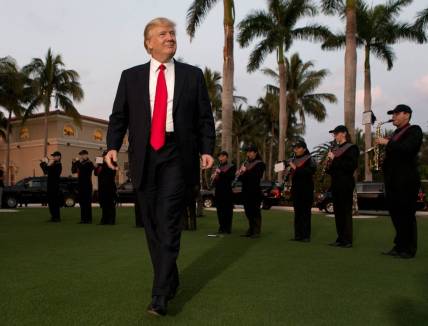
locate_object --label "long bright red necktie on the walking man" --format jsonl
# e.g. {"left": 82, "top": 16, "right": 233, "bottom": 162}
{"left": 150, "top": 65, "right": 168, "bottom": 151}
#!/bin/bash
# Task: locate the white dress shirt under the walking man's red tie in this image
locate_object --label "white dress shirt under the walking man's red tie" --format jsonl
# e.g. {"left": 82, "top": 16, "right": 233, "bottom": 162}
{"left": 149, "top": 57, "right": 175, "bottom": 132}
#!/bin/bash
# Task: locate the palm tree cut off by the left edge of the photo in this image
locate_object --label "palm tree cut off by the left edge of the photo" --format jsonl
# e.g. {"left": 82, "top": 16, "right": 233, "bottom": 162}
{"left": 0, "top": 57, "right": 29, "bottom": 185}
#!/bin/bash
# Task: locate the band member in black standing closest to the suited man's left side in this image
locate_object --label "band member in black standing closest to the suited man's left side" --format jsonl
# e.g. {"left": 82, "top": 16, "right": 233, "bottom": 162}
{"left": 94, "top": 151, "right": 116, "bottom": 225}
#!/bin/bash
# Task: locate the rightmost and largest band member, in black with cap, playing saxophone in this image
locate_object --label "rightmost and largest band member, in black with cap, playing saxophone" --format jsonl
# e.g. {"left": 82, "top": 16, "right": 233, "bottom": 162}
{"left": 376, "top": 104, "right": 423, "bottom": 258}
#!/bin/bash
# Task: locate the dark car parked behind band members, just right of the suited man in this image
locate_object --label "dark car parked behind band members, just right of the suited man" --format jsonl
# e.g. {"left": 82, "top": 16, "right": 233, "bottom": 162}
{"left": 201, "top": 180, "right": 282, "bottom": 209}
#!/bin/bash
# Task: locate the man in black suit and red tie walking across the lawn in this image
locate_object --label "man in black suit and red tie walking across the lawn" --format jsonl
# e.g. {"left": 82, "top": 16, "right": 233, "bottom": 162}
{"left": 106, "top": 18, "right": 215, "bottom": 315}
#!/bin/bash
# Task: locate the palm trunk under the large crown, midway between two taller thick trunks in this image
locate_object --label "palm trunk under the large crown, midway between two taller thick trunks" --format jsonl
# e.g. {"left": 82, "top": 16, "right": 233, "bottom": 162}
{"left": 278, "top": 48, "right": 288, "bottom": 182}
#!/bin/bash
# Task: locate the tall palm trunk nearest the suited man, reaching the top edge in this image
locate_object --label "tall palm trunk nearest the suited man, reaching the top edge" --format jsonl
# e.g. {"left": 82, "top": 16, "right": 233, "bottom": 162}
{"left": 221, "top": 0, "right": 234, "bottom": 158}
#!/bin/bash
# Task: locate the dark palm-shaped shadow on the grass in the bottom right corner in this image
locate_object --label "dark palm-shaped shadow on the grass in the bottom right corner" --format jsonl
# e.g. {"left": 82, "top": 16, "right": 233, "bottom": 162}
{"left": 390, "top": 275, "right": 428, "bottom": 326}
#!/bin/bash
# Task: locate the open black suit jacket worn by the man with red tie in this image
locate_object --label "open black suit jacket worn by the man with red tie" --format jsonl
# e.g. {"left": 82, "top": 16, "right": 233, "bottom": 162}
{"left": 107, "top": 61, "right": 215, "bottom": 189}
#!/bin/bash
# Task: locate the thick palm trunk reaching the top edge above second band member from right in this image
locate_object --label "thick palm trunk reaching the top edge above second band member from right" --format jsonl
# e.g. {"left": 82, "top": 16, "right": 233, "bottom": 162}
{"left": 344, "top": 0, "right": 357, "bottom": 142}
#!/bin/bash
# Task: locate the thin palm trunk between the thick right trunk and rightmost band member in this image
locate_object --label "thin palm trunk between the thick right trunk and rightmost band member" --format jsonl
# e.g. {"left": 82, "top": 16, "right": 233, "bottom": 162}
{"left": 364, "top": 46, "right": 373, "bottom": 181}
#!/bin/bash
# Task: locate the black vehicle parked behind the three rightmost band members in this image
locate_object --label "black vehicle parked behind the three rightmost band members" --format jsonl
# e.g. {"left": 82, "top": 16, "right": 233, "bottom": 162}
{"left": 315, "top": 182, "right": 426, "bottom": 214}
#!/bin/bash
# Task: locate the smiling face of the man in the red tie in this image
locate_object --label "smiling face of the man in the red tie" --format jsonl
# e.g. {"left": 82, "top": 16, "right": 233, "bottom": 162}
{"left": 146, "top": 25, "right": 177, "bottom": 62}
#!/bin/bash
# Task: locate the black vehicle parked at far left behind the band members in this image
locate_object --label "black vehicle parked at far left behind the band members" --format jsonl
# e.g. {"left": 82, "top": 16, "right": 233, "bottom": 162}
{"left": 2, "top": 176, "right": 78, "bottom": 208}
